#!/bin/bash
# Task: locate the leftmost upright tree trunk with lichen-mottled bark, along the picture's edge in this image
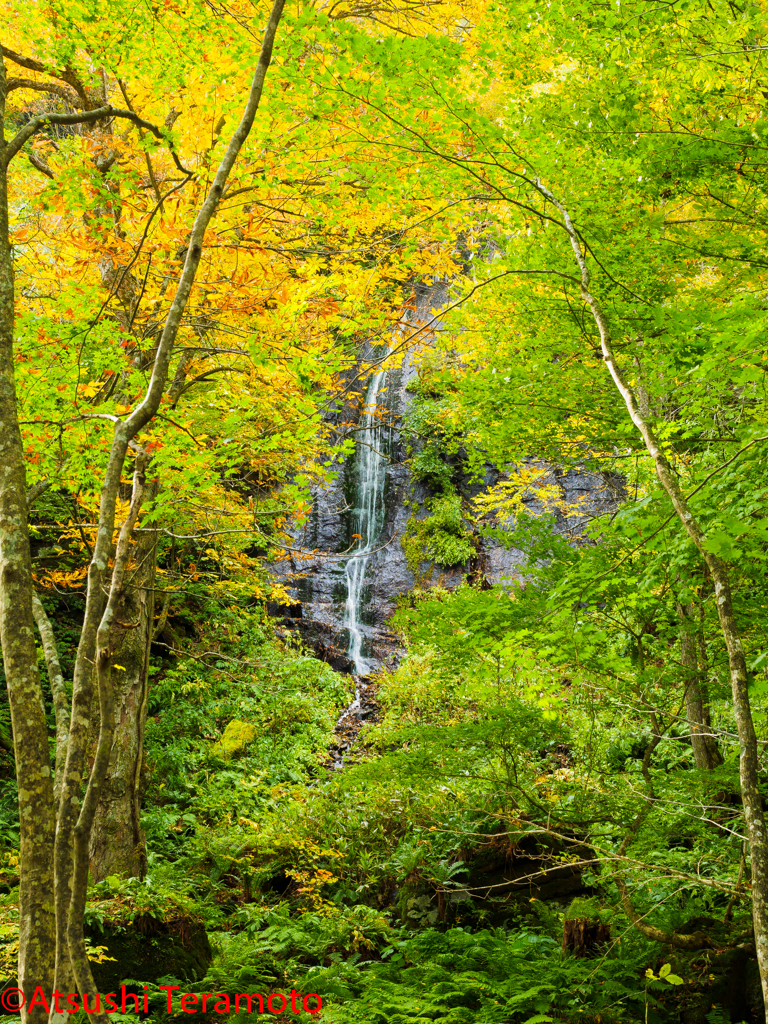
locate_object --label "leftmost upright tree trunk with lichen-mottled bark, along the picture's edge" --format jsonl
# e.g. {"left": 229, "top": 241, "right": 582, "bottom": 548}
{"left": 0, "top": 57, "right": 55, "bottom": 1024}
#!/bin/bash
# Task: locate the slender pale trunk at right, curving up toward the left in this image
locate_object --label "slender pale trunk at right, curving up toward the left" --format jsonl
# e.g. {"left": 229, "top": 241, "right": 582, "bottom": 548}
{"left": 536, "top": 181, "right": 768, "bottom": 1022}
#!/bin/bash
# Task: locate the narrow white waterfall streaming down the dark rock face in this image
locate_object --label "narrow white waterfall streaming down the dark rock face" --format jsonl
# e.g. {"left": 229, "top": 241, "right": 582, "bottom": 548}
{"left": 344, "top": 370, "right": 387, "bottom": 676}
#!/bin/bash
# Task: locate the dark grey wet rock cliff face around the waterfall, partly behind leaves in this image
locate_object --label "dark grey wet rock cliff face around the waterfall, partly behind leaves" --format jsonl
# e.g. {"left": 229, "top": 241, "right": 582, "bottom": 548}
{"left": 279, "top": 283, "right": 620, "bottom": 673}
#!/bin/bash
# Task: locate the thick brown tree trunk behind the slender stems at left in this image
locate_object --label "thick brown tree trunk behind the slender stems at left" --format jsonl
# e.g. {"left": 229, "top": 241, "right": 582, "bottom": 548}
{"left": 90, "top": 520, "right": 157, "bottom": 882}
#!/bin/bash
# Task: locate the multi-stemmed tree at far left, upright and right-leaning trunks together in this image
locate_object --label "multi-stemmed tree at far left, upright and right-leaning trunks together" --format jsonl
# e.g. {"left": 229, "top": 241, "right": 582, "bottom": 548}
{"left": 0, "top": 0, "right": 283, "bottom": 1020}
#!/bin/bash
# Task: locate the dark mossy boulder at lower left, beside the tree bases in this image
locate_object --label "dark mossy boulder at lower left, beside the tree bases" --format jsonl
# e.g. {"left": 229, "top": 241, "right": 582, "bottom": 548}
{"left": 88, "top": 914, "right": 213, "bottom": 992}
